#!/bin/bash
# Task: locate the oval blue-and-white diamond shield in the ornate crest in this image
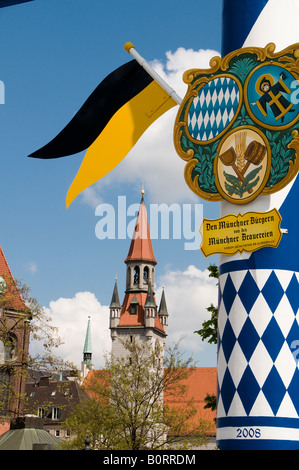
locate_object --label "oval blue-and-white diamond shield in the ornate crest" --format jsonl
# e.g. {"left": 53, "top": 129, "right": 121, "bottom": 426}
{"left": 188, "top": 77, "right": 240, "bottom": 141}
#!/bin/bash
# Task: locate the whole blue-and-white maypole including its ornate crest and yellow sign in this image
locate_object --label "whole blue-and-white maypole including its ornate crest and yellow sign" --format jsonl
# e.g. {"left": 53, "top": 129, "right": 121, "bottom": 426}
{"left": 174, "top": 0, "right": 299, "bottom": 450}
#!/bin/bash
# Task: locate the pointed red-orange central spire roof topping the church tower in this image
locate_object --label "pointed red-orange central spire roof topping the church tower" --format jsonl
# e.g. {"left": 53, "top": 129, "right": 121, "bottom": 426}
{"left": 125, "top": 191, "right": 157, "bottom": 264}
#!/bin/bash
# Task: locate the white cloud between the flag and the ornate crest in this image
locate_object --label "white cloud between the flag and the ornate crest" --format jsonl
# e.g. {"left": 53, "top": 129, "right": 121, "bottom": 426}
{"left": 81, "top": 47, "right": 219, "bottom": 207}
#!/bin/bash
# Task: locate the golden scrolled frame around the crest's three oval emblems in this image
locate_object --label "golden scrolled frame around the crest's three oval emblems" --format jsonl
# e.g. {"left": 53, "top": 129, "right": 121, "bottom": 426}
{"left": 174, "top": 43, "right": 299, "bottom": 204}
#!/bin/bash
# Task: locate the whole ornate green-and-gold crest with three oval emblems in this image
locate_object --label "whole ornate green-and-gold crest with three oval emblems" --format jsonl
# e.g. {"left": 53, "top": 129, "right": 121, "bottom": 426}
{"left": 174, "top": 43, "right": 299, "bottom": 204}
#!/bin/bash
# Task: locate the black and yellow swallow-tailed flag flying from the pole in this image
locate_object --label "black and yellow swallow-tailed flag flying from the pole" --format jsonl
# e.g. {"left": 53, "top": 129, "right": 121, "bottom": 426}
{"left": 29, "top": 60, "right": 177, "bottom": 207}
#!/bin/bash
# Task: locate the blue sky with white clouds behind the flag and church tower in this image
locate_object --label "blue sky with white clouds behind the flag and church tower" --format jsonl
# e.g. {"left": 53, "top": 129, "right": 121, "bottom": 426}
{"left": 0, "top": 0, "right": 222, "bottom": 369}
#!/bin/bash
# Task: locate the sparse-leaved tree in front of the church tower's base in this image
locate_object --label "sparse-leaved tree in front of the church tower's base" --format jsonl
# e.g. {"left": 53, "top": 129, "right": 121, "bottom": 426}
{"left": 64, "top": 337, "right": 212, "bottom": 450}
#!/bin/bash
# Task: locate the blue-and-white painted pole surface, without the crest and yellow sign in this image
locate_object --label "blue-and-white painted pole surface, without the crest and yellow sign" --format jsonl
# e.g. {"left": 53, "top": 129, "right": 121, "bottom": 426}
{"left": 217, "top": 0, "right": 299, "bottom": 449}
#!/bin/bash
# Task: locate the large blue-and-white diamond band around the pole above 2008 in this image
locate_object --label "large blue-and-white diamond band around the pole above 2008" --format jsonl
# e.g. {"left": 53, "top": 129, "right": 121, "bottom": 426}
{"left": 217, "top": 269, "right": 299, "bottom": 418}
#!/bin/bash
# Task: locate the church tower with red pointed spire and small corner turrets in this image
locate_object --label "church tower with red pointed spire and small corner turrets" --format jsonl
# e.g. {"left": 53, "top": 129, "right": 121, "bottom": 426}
{"left": 110, "top": 191, "right": 168, "bottom": 356}
